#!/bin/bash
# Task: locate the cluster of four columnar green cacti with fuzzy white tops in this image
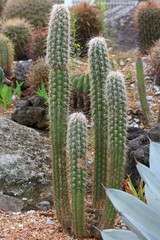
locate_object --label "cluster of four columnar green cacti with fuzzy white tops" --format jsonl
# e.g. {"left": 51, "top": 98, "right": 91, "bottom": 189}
{"left": 47, "top": 5, "right": 126, "bottom": 239}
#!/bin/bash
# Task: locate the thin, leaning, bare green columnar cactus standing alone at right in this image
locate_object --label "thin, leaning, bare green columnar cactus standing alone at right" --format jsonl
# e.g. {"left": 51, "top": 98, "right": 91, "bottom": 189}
{"left": 136, "top": 58, "right": 152, "bottom": 123}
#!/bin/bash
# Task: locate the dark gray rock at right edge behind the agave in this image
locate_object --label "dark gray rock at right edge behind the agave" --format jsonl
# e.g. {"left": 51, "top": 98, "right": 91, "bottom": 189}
{"left": 125, "top": 124, "right": 160, "bottom": 187}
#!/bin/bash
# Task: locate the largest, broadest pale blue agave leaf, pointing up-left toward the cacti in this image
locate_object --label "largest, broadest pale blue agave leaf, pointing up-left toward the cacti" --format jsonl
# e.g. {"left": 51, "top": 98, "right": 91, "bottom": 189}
{"left": 105, "top": 188, "right": 160, "bottom": 240}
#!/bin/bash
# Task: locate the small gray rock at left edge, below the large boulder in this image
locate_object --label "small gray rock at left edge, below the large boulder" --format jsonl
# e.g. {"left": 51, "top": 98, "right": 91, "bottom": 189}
{"left": 0, "top": 193, "right": 24, "bottom": 212}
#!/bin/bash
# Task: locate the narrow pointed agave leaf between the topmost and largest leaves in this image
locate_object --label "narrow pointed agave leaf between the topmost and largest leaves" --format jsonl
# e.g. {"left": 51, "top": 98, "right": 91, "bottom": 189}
{"left": 137, "top": 163, "right": 160, "bottom": 201}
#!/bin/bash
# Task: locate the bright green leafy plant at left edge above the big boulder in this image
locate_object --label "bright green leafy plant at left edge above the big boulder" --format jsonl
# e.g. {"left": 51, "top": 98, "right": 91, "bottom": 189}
{"left": 0, "top": 84, "right": 13, "bottom": 108}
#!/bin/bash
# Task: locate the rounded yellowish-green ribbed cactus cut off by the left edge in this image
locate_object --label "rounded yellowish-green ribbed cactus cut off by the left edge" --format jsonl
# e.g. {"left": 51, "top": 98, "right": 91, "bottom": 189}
{"left": 0, "top": 34, "right": 14, "bottom": 75}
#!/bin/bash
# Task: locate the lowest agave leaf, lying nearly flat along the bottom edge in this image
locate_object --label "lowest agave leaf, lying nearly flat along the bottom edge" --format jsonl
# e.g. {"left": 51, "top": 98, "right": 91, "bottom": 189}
{"left": 101, "top": 229, "right": 140, "bottom": 240}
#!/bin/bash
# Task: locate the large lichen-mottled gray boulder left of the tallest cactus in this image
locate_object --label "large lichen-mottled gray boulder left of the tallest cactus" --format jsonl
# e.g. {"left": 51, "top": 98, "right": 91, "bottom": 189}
{"left": 0, "top": 116, "right": 52, "bottom": 209}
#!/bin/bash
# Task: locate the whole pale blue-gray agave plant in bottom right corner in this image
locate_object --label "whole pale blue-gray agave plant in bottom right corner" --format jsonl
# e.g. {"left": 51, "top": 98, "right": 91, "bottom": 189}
{"left": 101, "top": 142, "right": 160, "bottom": 240}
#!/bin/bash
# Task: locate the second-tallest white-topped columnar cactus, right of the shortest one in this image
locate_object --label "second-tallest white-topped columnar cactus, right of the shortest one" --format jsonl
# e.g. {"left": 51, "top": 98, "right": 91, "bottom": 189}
{"left": 89, "top": 37, "right": 109, "bottom": 205}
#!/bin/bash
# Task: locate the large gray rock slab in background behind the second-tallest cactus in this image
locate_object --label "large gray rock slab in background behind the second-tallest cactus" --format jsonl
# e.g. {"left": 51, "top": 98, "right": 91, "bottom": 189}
{"left": 105, "top": 5, "right": 138, "bottom": 52}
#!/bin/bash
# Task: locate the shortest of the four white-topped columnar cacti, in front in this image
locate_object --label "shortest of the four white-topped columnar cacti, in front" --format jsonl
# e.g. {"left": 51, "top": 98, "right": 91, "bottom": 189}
{"left": 67, "top": 113, "right": 87, "bottom": 238}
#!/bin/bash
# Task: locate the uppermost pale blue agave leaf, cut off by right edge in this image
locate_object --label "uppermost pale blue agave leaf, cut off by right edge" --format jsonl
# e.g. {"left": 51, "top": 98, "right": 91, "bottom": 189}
{"left": 149, "top": 142, "right": 160, "bottom": 177}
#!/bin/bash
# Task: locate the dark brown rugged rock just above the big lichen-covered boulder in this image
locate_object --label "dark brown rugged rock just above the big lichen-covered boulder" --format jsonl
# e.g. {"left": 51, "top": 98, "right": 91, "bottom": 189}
{"left": 12, "top": 95, "right": 49, "bottom": 129}
